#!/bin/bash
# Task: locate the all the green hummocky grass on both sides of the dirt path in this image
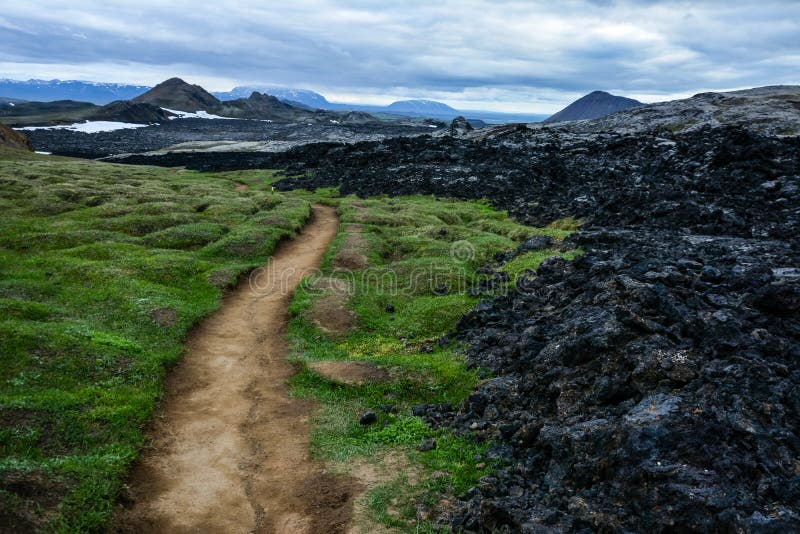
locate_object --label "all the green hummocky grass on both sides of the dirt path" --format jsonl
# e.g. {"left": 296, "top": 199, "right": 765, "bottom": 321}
{"left": 0, "top": 149, "right": 578, "bottom": 532}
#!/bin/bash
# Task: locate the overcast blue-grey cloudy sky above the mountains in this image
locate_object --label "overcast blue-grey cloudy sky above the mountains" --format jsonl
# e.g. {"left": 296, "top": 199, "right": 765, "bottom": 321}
{"left": 0, "top": 0, "right": 800, "bottom": 113}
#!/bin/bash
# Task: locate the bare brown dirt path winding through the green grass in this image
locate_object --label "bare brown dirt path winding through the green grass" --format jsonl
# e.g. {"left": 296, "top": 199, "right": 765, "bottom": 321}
{"left": 115, "top": 206, "right": 359, "bottom": 533}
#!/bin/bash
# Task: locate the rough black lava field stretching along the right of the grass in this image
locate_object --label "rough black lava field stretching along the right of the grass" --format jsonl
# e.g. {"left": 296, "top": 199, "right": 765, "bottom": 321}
{"left": 120, "top": 127, "right": 800, "bottom": 533}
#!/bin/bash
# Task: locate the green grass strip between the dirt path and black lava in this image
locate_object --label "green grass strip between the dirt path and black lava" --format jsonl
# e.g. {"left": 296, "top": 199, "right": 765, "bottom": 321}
{"left": 289, "top": 196, "right": 579, "bottom": 532}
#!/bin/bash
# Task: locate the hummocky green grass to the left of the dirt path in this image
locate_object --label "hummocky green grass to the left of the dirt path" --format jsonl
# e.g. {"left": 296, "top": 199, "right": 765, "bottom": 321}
{"left": 0, "top": 151, "right": 325, "bottom": 532}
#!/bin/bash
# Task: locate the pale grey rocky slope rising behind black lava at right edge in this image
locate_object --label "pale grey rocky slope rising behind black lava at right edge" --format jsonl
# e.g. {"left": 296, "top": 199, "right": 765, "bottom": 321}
{"left": 548, "top": 85, "right": 800, "bottom": 135}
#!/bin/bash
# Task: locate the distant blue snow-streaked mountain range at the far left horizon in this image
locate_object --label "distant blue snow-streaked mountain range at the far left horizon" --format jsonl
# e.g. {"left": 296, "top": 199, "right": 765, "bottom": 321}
{"left": 0, "top": 79, "right": 149, "bottom": 104}
